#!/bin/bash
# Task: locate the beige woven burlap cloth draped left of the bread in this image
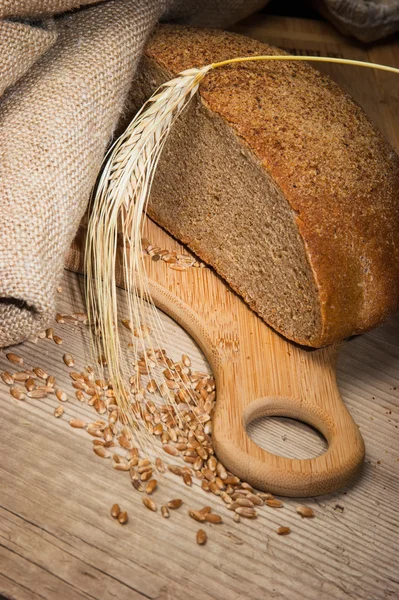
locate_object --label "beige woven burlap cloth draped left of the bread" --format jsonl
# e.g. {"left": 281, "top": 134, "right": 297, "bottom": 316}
{"left": 0, "top": 0, "right": 267, "bottom": 347}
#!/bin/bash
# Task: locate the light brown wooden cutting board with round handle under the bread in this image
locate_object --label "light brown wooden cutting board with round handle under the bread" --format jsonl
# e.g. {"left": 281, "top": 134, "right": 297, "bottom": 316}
{"left": 67, "top": 219, "right": 364, "bottom": 496}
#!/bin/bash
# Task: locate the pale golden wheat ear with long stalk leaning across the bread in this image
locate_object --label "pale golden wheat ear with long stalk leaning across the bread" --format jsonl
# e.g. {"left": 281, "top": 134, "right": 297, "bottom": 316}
{"left": 85, "top": 55, "right": 399, "bottom": 443}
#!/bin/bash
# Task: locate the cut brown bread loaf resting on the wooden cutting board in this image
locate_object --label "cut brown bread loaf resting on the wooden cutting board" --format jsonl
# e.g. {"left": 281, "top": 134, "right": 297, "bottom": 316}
{"left": 130, "top": 26, "right": 399, "bottom": 347}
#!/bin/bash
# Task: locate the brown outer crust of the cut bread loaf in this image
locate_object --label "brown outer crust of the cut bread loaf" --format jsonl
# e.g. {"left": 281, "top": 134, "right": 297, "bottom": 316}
{"left": 142, "top": 26, "right": 399, "bottom": 346}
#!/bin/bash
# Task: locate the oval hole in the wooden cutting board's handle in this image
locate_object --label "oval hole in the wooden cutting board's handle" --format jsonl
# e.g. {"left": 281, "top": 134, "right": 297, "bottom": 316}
{"left": 246, "top": 416, "right": 328, "bottom": 458}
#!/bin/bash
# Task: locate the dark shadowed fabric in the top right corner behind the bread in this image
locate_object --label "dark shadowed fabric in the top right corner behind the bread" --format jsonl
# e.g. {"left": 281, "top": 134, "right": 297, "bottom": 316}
{"left": 314, "top": 0, "right": 399, "bottom": 42}
